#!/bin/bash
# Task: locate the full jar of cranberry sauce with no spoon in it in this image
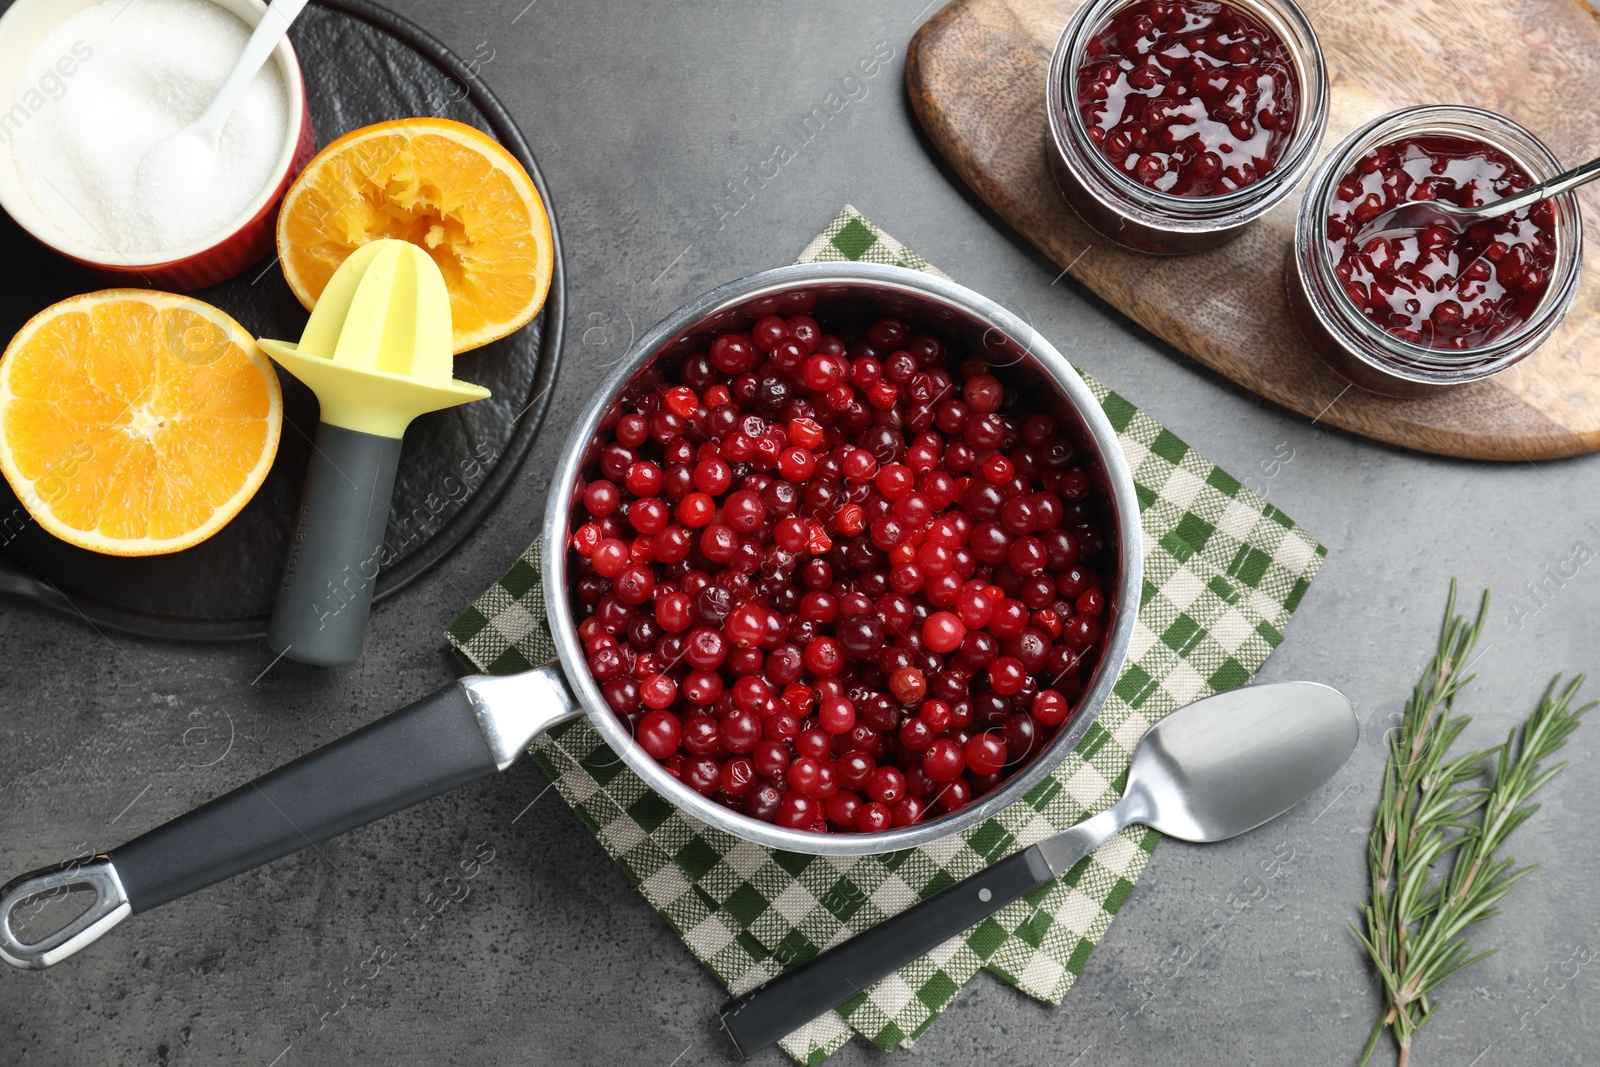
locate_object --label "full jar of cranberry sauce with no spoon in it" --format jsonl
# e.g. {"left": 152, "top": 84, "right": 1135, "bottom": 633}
{"left": 1046, "top": 0, "right": 1328, "bottom": 254}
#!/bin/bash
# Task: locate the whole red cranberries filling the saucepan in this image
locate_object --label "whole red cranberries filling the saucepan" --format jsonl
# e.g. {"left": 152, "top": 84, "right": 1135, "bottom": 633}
{"left": 571, "top": 298, "right": 1115, "bottom": 832}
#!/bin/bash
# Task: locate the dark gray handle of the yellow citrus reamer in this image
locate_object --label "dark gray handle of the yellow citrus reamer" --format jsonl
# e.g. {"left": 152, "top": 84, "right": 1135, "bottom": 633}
{"left": 267, "top": 422, "right": 402, "bottom": 667}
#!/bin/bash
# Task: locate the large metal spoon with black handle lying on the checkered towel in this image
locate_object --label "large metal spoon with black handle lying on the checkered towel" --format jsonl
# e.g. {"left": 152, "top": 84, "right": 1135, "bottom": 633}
{"left": 722, "top": 681, "right": 1360, "bottom": 1056}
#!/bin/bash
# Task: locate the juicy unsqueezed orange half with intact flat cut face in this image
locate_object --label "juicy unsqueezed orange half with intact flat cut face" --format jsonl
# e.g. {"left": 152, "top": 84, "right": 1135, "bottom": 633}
{"left": 0, "top": 290, "right": 283, "bottom": 555}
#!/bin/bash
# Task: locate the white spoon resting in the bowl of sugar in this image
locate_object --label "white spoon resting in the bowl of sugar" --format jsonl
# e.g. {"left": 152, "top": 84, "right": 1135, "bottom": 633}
{"left": 136, "top": 0, "right": 307, "bottom": 214}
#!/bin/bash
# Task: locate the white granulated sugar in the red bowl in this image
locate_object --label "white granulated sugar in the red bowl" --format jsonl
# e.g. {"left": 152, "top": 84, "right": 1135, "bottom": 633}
{"left": 10, "top": 0, "right": 288, "bottom": 254}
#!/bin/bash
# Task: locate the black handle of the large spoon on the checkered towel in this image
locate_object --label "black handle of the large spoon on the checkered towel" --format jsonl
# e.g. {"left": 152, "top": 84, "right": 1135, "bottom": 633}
{"left": 722, "top": 846, "right": 1053, "bottom": 1056}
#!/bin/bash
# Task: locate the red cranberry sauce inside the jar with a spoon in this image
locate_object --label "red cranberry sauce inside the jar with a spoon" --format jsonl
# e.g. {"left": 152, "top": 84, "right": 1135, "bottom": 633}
{"left": 1328, "top": 136, "right": 1555, "bottom": 350}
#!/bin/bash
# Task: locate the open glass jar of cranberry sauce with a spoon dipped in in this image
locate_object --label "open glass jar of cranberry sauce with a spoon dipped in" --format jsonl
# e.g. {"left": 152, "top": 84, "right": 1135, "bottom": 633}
{"left": 1286, "top": 106, "right": 1582, "bottom": 397}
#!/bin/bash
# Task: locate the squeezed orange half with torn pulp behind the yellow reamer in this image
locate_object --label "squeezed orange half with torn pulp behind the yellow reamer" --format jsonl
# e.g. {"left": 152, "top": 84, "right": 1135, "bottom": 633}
{"left": 278, "top": 118, "right": 554, "bottom": 352}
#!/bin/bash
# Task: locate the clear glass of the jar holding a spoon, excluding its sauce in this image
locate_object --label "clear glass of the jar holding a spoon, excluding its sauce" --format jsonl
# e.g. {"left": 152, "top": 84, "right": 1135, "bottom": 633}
{"left": 1285, "top": 106, "right": 1584, "bottom": 397}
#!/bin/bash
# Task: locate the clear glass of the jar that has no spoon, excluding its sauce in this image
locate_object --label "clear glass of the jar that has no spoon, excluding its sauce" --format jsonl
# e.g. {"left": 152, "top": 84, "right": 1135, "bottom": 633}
{"left": 1046, "top": 0, "right": 1328, "bottom": 254}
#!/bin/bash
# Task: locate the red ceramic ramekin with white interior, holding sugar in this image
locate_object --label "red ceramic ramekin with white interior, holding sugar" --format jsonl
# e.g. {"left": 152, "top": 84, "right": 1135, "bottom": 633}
{"left": 0, "top": 0, "right": 315, "bottom": 293}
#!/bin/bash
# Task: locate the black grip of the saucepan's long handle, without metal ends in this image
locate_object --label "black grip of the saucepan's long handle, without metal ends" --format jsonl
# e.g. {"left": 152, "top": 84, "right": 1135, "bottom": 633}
{"left": 110, "top": 683, "right": 496, "bottom": 912}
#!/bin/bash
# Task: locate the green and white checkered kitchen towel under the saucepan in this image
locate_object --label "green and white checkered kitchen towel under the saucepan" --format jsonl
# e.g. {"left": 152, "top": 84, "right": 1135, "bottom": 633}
{"left": 448, "top": 206, "right": 1326, "bottom": 1064}
